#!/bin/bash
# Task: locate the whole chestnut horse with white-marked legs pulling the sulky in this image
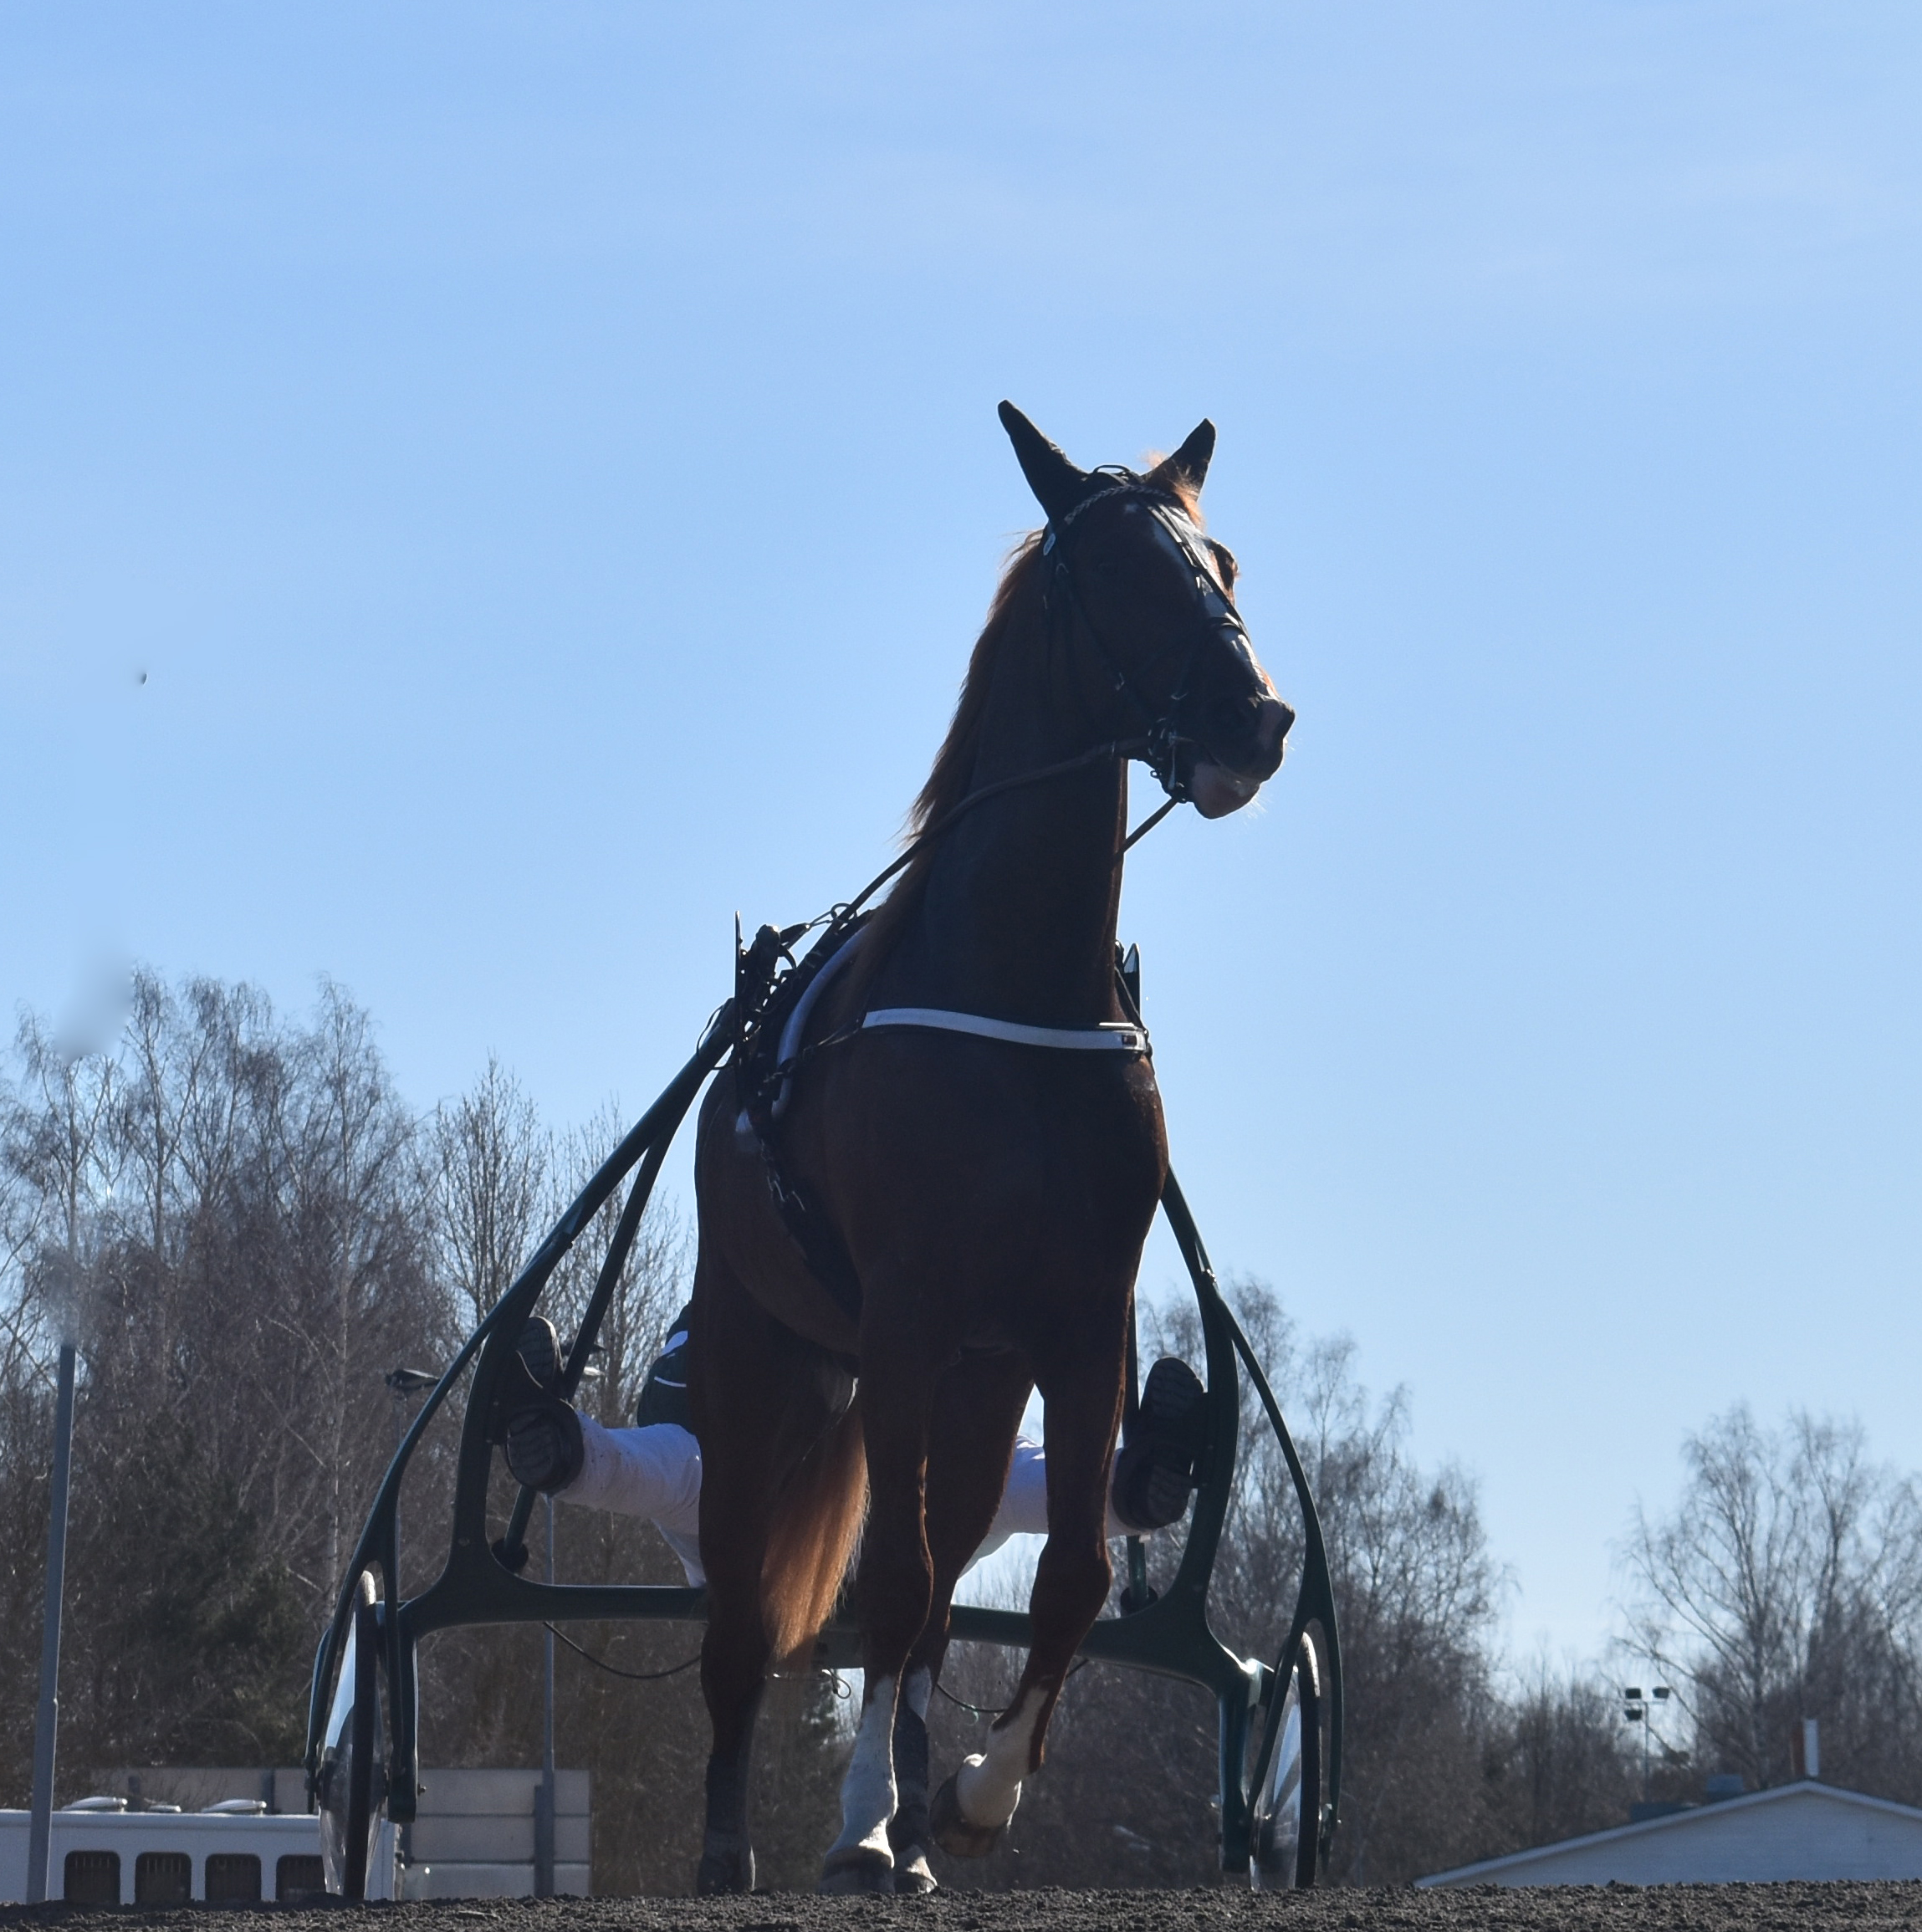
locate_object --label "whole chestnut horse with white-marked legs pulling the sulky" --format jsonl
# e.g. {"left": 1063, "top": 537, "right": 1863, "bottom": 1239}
{"left": 690, "top": 401, "right": 1294, "bottom": 1891}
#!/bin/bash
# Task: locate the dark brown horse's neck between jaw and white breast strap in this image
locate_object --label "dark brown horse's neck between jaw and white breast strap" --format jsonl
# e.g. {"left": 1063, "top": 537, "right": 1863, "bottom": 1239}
{"left": 887, "top": 609, "right": 1126, "bottom": 1026}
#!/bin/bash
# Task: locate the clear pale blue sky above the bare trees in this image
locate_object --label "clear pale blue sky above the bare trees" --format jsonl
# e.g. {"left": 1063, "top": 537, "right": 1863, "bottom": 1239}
{"left": 0, "top": 0, "right": 1922, "bottom": 1653}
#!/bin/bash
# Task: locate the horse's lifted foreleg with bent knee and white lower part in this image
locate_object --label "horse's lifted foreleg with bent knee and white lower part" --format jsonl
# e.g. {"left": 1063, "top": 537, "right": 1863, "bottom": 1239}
{"left": 929, "top": 1321, "right": 1122, "bottom": 1858}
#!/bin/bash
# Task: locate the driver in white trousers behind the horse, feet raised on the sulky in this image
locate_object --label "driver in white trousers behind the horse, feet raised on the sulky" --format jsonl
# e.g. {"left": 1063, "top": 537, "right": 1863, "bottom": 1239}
{"left": 506, "top": 1308, "right": 1207, "bottom": 1584}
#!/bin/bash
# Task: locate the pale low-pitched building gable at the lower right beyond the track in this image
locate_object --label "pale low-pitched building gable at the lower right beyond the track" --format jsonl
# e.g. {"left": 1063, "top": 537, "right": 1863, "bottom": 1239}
{"left": 1416, "top": 1777, "right": 1922, "bottom": 1886}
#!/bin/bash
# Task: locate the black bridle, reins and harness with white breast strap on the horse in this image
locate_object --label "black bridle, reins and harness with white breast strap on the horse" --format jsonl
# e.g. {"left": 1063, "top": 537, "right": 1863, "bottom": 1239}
{"left": 732, "top": 469, "right": 1254, "bottom": 1321}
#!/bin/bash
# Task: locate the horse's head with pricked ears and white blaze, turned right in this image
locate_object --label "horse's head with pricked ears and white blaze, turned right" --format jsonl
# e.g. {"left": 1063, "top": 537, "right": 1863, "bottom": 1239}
{"left": 1000, "top": 401, "right": 1294, "bottom": 819}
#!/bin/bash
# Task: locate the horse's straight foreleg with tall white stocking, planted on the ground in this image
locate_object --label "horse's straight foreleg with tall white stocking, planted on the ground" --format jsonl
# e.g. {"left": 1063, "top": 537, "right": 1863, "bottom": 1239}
{"left": 819, "top": 1335, "right": 933, "bottom": 1891}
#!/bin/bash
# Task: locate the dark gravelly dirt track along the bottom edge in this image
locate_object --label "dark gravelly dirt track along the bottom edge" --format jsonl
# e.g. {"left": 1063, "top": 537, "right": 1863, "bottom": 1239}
{"left": 11, "top": 1883, "right": 1922, "bottom": 1932}
